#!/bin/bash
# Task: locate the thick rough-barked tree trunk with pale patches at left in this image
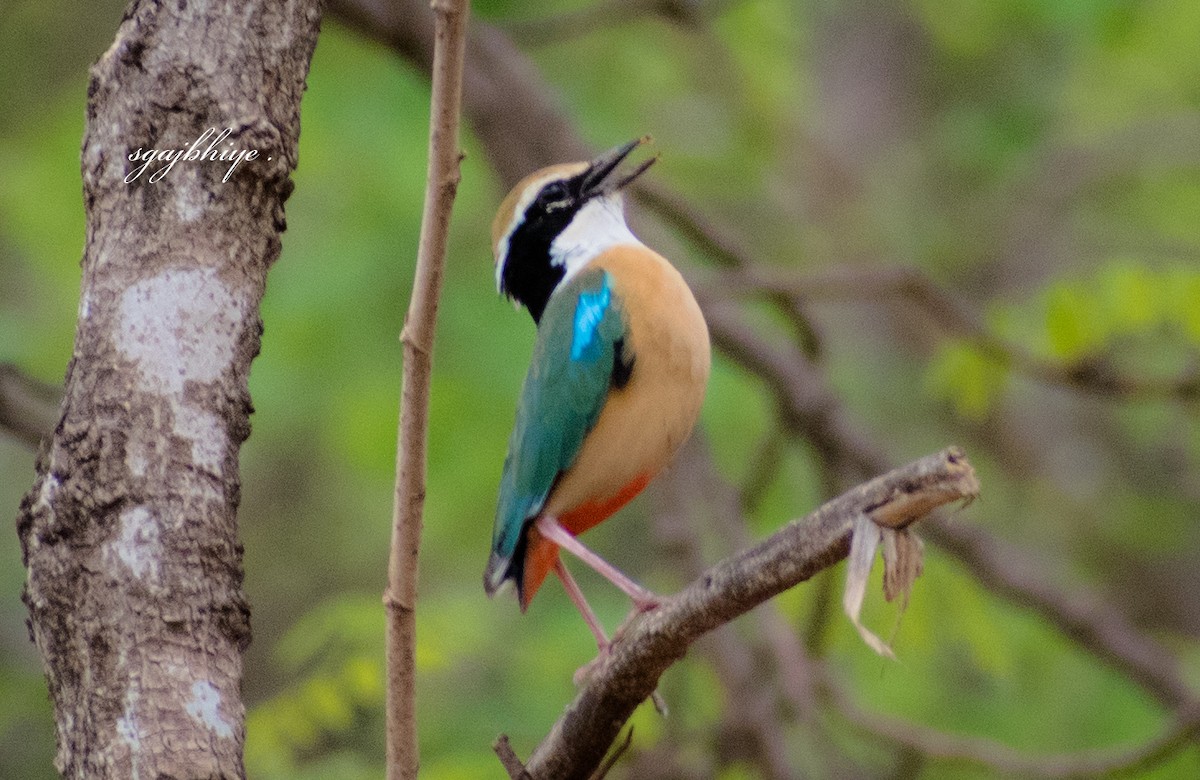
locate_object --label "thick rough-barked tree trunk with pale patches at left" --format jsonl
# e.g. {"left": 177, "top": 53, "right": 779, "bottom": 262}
{"left": 18, "top": 0, "right": 320, "bottom": 779}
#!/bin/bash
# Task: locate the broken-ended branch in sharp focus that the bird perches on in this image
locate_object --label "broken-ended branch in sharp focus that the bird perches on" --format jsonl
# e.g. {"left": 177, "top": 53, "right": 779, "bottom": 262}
{"left": 526, "top": 448, "right": 979, "bottom": 780}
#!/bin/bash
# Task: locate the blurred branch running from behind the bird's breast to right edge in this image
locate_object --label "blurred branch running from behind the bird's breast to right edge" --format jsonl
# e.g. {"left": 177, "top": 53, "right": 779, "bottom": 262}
{"left": 710, "top": 268, "right": 1200, "bottom": 401}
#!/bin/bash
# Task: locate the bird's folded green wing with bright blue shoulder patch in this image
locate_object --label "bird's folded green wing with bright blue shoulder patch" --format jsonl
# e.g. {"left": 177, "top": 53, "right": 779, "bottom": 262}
{"left": 484, "top": 269, "right": 628, "bottom": 593}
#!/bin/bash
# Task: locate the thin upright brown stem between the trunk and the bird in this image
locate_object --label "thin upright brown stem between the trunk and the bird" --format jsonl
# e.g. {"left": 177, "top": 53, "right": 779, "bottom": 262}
{"left": 384, "top": 0, "right": 468, "bottom": 780}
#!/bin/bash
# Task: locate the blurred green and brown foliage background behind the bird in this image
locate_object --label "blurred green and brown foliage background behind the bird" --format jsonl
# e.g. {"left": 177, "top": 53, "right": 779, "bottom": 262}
{"left": 0, "top": 0, "right": 1200, "bottom": 780}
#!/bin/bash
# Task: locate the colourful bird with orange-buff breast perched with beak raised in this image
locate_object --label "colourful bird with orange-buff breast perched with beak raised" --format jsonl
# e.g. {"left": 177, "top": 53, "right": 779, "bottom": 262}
{"left": 484, "top": 137, "right": 712, "bottom": 654}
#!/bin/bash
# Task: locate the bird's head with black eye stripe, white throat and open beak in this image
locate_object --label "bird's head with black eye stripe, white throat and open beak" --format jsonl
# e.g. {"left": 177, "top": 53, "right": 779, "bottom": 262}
{"left": 492, "top": 137, "right": 658, "bottom": 322}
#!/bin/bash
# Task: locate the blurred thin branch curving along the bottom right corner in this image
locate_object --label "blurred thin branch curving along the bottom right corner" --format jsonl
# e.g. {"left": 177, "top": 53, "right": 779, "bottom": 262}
{"left": 821, "top": 676, "right": 1200, "bottom": 778}
